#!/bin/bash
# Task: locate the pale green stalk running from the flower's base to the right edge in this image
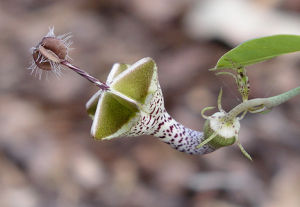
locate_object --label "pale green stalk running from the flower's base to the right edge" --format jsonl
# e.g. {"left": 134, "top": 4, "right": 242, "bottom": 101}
{"left": 225, "top": 86, "right": 300, "bottom": 121}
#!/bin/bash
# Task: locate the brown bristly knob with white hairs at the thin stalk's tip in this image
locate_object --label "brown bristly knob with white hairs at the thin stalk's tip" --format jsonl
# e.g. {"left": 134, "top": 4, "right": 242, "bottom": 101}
{"left": 28, "top": 27, "right": 72, "bottom": 78}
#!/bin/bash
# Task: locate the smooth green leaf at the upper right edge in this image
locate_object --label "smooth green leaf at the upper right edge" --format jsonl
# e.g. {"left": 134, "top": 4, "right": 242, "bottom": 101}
{"left": 212, "top": 35, "right": 300, "bottom": 70}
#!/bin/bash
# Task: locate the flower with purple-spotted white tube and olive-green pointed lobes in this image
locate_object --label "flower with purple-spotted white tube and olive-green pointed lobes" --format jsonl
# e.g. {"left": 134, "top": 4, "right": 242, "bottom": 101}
{"left": 86, "top": 58, "right": 216, "bottom": 154}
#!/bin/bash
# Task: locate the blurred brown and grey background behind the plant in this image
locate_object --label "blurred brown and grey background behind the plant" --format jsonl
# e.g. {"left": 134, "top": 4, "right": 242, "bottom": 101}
{"left": 0, "top": 0, "right": 300, "bottom": 207}
